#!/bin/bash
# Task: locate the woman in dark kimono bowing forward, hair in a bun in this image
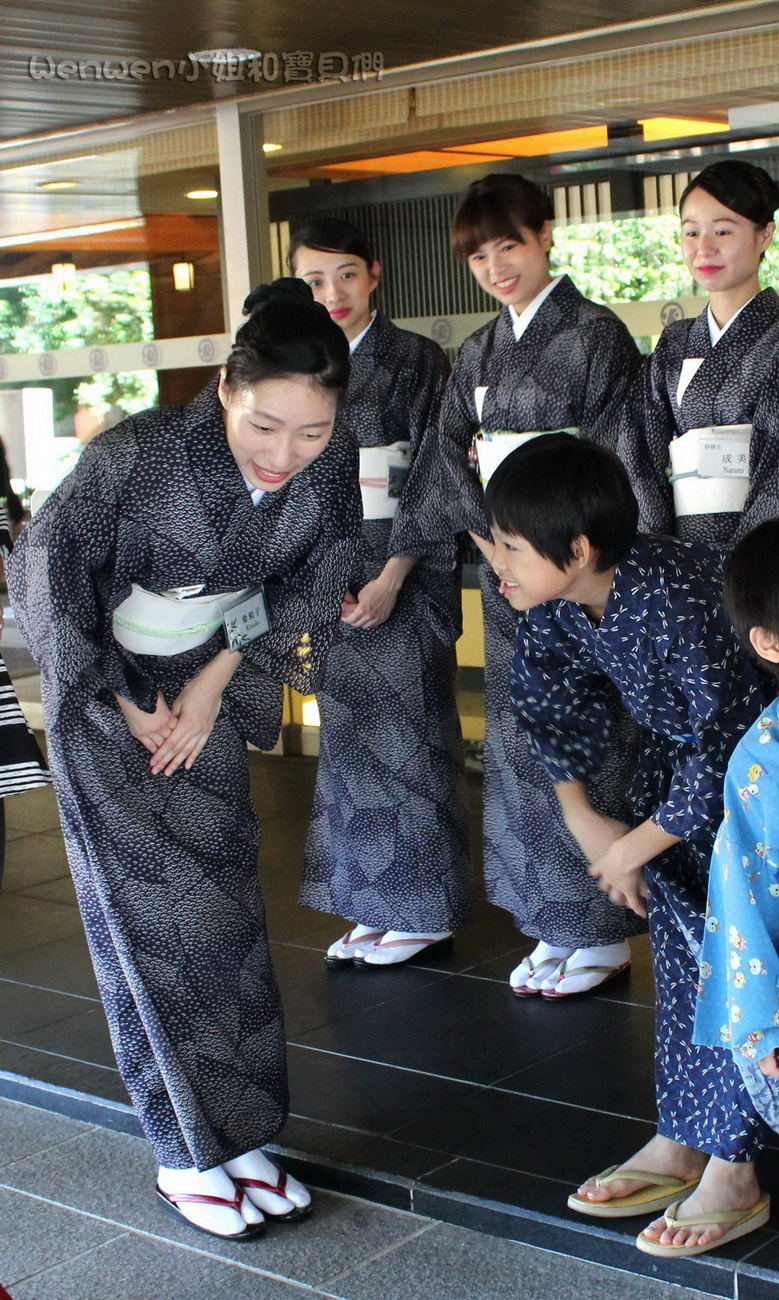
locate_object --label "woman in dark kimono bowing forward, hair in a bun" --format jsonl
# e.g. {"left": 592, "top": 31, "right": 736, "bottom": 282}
{"left": 9, "top": 280, "right": 359, "bottom": 1242}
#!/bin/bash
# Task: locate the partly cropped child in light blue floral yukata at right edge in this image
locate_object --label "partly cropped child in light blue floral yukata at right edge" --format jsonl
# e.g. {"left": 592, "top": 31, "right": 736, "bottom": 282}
{"left": 694, "top": 519, "right": 779, "bottom": 1107}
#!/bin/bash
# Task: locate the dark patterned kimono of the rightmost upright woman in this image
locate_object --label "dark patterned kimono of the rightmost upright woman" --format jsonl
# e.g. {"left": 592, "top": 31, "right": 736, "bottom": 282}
{"left": 618, "top": 289, "right": 779, "bottom": 553}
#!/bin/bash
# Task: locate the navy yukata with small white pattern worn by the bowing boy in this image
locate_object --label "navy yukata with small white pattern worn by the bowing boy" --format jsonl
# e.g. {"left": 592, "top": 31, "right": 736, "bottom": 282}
{"left": 511, "top": 537, "right": 762, "bottom": 1161}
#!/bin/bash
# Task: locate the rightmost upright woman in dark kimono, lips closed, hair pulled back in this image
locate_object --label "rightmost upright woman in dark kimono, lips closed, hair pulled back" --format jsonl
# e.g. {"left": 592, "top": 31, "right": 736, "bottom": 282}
{"left": 618, "top": 159, "right": 779, "bottom": 553}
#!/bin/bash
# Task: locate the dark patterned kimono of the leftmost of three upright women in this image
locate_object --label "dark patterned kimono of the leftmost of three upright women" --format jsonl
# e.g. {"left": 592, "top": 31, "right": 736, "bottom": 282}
{"left": 300, "top": 313, "right": 472, "bottom": 932}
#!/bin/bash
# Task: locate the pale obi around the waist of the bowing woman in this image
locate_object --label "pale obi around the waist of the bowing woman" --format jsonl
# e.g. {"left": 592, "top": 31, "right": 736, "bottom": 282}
{"left": 113, "top": 582, "right": 268, "bottom": 657}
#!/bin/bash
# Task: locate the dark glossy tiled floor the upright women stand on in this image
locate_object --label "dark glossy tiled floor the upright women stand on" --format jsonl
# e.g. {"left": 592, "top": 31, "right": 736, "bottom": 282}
{"left": 0, "top": 754, "right": 779, "bottom": 1300}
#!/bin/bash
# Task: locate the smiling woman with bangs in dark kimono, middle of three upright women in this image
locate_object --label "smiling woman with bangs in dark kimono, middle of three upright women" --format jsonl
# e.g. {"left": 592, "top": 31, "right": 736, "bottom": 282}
{"left": 400, "top": 174, "right": 642, "bottom": 997}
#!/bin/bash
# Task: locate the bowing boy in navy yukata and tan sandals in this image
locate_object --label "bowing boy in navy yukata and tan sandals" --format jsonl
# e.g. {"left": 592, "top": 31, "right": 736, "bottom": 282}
{"left": 485, "top": 433, "right": 769, "bottom": 1256}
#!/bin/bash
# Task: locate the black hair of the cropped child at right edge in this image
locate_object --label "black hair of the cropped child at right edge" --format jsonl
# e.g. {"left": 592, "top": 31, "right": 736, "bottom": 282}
{"left": 724, "top": 519, "right": 779, "bottom": 660}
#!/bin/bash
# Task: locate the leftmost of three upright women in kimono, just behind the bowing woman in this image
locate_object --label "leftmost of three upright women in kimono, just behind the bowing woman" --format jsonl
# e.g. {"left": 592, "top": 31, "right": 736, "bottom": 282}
{"left": 289, "top": 218, "right": 472, "bottom": 967}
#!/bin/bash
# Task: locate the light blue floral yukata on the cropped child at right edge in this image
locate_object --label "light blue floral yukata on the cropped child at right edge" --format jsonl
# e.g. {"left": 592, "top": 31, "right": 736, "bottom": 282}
{"left": 694, "top": 701, "right": 779, "bottom": 1128}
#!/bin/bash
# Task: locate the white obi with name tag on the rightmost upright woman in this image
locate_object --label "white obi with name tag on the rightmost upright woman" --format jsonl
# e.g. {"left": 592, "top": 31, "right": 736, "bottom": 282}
{"left": 668, "top": 424, "right": 752, "bottom": 517}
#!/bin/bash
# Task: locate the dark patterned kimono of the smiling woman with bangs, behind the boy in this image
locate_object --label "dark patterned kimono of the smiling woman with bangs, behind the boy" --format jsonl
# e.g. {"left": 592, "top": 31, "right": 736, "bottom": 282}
{"left": 392, "top": 276, "right": 642, "bottom": 948}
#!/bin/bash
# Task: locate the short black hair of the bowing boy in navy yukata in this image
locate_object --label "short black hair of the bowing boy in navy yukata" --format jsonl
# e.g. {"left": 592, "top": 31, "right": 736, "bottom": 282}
{"left": 485, "top": 433, "right": 639, "bottom": 573}
